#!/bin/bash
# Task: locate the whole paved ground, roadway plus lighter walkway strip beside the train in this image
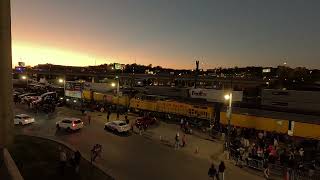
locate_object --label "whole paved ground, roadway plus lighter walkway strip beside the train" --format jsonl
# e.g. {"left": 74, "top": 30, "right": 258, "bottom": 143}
{"left": 14, "top": 105, "right": 263, "bottom": 180}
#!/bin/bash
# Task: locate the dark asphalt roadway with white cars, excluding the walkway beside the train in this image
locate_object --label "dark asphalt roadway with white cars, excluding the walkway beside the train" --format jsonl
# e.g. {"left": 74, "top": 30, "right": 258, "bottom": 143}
{"left": 14, "top": 105, "right": 260, "bottom": 180}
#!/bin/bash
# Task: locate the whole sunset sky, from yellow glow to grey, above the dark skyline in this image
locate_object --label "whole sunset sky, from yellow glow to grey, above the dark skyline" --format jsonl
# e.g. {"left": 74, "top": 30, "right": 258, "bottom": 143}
{"left": 11, "top": 0, "right": 320, "bottom": 69}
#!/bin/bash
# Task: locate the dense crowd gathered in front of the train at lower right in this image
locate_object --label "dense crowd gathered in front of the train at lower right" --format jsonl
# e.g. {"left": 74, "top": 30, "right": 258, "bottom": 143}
{"left": 218, "top": 126, "right": 320, "bottom": 179}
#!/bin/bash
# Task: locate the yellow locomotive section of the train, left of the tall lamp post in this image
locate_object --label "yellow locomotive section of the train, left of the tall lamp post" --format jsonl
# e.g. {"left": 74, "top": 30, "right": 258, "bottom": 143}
{"left": 82, "top": 90, "right": 214, "bottom": 121}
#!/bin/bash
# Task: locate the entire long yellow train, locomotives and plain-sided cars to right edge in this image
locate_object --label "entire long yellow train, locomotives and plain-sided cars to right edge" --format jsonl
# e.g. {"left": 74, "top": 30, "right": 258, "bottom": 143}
{"left": 82, "top": 90, "right": 320, "bottom": 140}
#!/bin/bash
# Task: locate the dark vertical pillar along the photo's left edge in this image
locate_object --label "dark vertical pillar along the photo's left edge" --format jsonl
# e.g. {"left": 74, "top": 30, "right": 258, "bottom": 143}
{"left": 0, "top": 0, "right": 13, "bottom": 149}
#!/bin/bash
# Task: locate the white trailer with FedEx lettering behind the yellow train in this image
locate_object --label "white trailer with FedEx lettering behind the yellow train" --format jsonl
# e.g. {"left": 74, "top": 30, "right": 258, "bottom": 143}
{"left": 189, "top": 88, "right": 243, "bottom": 102}
